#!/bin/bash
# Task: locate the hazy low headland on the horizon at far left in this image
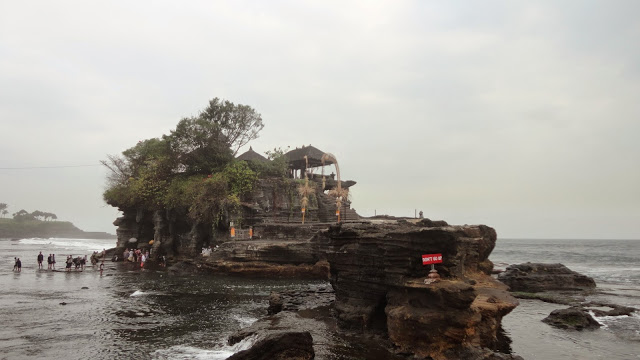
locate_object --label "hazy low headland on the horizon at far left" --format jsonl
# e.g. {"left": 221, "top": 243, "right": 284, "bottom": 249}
{"left": 0, "top": 219, "right": 116, "bottom": 239}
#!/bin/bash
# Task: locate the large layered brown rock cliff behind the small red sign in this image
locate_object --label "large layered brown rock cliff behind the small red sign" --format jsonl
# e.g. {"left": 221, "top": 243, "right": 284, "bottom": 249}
{"left": 314, "top": 222, "right": 518, "bottom": 359}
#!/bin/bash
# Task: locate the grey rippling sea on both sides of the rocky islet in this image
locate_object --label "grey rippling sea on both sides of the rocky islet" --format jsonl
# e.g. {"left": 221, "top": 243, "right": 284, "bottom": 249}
{"left": 0, "top": 238, "right": 640, "bottom": 360}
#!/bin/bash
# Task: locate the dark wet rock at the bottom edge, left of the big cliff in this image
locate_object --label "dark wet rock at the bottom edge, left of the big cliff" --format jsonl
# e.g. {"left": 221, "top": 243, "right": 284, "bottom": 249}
{"left": 228, "top": 331, "right": 315, "bottom": 360}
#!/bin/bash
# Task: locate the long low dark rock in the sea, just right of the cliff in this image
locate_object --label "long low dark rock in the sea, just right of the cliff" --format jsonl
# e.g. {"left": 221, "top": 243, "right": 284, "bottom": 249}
{"left": 498, "top": 263, "right": 596, "bottom": 293}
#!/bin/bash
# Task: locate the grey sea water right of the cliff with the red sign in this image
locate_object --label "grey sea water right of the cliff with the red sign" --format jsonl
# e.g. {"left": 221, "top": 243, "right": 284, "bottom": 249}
{"left": 489, "top": 239, "right": 640, "bottom": 360}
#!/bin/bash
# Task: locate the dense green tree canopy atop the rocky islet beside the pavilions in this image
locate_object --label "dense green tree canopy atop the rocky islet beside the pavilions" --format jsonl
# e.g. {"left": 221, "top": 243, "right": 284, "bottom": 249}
{"left": 102, "top": 98, "right": 264, "bottom": 223}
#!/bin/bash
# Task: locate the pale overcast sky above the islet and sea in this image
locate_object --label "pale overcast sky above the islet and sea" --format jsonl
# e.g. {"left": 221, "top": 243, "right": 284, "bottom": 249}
{"left": 0, "top": 0, "right": 640, "bottom": 239}
